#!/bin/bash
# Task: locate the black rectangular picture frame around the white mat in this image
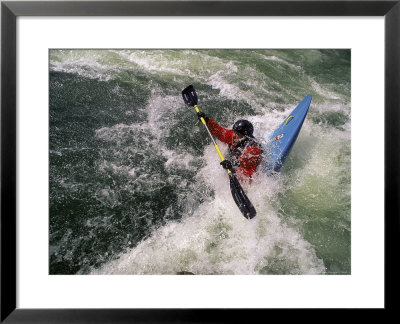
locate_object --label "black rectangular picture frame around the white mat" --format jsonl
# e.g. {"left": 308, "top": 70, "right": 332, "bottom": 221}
{"left": 0, "top": 0, "right": 400, "bottom": 323}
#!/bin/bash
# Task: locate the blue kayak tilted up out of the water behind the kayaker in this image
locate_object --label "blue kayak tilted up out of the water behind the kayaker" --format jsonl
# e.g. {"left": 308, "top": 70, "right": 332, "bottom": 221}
{"left": 262, "top": 94, "right": 311, "bottom": 173}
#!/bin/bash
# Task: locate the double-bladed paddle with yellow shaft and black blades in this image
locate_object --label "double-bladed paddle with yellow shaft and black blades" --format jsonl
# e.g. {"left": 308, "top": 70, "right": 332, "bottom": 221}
{"left": 182, "top": 85, "right": 257, "bottom": 219}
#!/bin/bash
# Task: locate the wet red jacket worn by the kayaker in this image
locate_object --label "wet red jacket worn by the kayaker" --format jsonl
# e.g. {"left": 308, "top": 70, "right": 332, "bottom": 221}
{"left": 207, "top": 118, "right": 262, "bottom": 177}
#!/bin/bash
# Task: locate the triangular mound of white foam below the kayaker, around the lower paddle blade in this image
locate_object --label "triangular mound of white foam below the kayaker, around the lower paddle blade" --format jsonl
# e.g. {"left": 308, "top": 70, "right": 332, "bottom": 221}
{"left": 93, "top": 140, "right": 325, "bottom": 274}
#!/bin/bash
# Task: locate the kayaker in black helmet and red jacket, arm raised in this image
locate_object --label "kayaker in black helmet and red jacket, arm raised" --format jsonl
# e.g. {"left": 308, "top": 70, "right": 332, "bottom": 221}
{"left": 197, "top": 112, "right": 262, "bottom": 178}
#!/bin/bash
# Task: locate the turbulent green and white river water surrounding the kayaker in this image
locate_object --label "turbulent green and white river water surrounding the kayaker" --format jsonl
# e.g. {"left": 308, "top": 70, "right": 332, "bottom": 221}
{"left": 49, "top": 50, "right": 351, "bottom": 275}
